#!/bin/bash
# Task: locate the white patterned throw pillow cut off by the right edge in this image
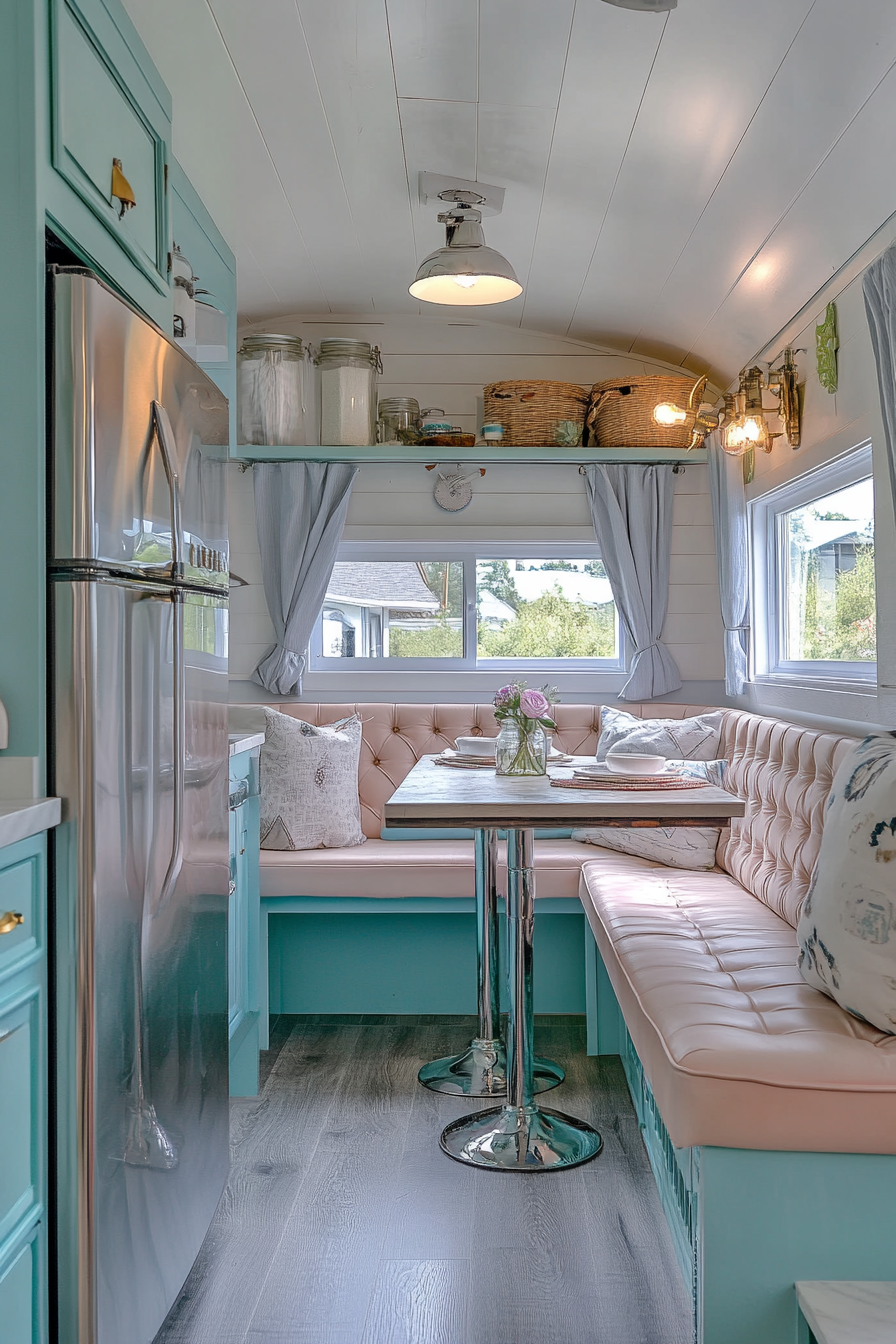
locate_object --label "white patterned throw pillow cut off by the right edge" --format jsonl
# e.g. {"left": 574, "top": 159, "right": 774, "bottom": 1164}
{"left": 797, "top": 732, "right": 896, "bottom": 1035}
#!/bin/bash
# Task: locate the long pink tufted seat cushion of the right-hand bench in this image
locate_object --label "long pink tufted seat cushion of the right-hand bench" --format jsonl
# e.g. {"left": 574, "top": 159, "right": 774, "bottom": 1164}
{"left": 580, "top": 855, "right": 896, "bottom": 1153}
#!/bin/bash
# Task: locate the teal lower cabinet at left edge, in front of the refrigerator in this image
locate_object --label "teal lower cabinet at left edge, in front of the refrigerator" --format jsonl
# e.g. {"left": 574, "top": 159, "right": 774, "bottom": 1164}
{"left": 0, "top": 835, "right": 47, "bottom": 1344}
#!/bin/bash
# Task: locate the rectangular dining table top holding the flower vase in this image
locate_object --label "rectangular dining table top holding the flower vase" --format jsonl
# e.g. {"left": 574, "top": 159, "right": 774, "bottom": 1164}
{"left": 384, "top": 757, "right": 744, "bottom": 827}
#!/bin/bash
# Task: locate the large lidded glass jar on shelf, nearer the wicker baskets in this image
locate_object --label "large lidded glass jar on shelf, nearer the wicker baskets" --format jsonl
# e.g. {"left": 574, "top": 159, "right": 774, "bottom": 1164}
{"left": 317, "top": 337, "right": 383, "bottom": 448}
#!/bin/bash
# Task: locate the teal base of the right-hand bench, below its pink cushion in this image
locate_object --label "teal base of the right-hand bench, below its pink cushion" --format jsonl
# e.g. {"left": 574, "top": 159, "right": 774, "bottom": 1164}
{"left": 588, "top": 933, "right": 896, "bottom": 1344}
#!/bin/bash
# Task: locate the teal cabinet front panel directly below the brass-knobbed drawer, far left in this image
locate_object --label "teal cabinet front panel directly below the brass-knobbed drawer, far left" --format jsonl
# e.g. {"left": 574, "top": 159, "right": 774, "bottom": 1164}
{"left": 0, "top": 985, "right": 42, "bottom": 1247}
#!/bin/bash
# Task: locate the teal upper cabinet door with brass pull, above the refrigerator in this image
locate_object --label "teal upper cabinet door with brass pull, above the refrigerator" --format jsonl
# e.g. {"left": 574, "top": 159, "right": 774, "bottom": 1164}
{"left": 51, "top": 0, "right": 171, "bottom": 294}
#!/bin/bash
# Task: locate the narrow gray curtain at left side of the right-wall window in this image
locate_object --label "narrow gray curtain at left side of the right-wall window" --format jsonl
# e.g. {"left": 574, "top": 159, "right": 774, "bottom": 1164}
{"left": 707, "top": 434, "right": 750, "bottom": 695}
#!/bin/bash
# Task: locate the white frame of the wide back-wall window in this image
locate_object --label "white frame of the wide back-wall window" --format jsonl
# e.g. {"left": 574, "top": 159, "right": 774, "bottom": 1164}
{"left": 309, "top": 540, "right": 626, "bottom": 680}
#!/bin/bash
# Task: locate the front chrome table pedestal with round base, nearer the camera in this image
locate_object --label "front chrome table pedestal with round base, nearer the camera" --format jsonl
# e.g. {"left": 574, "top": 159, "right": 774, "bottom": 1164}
{"left": 441, "top": 829, "right": 602, "bottom": 1172}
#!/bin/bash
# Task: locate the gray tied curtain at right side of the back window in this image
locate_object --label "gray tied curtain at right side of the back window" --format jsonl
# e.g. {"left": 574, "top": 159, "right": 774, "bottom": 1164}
{"left": 584, "top": 464, "right": 681, "bottom": 700}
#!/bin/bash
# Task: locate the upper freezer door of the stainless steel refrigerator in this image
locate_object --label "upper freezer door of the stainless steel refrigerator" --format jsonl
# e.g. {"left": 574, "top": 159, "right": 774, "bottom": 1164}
{"left": 50, "top": 267, "right": 228, "bottom": 590}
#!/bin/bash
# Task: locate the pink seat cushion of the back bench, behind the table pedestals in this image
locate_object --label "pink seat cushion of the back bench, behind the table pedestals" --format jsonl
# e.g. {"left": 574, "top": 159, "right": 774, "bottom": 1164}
{"left": 261, "top": 840, "right": 596, "bottom": 900}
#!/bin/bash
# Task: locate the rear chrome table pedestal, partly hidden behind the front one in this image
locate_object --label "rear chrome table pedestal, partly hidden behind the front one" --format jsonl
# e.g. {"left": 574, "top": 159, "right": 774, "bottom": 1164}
{"left": 418, "top": 828, "right": 566, "bottom": 1097}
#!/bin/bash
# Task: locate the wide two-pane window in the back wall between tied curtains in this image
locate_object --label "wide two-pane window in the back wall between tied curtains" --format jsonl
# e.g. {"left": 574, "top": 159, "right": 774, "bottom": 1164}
{"left": 312, "top": 543, "right": 623, "bottom": 672}
